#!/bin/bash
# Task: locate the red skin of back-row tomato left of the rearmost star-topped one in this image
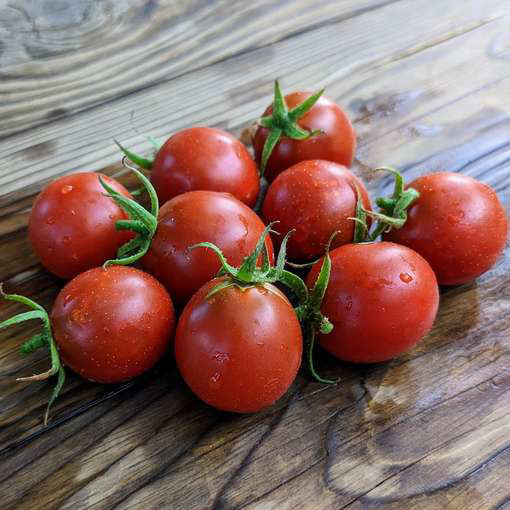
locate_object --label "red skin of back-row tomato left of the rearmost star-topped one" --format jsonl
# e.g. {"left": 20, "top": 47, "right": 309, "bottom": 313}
{"left": 151, "top": 127, "right": 260, "bottom": 207}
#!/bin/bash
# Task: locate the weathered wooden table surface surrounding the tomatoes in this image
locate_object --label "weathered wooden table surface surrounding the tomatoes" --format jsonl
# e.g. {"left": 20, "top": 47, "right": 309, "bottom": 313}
{"left": 0, "top": 0, "right": 510, "bottom": 510}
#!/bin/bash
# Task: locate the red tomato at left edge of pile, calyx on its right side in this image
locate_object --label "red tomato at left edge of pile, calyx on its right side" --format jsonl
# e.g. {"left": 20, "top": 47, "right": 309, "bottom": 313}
{"left": 28, "top": 172, "right": 133, "bottom": 279}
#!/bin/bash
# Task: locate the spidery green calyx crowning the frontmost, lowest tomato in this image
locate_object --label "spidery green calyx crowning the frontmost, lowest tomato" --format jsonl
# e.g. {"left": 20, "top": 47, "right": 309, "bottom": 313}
{"left": 188, "top": 223, "right": 308, "bottom": 302}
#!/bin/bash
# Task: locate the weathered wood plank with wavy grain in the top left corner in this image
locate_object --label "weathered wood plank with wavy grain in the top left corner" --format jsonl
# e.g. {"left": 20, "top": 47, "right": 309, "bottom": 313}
{"left": 0, "top": 0, "right": 395, "bottom": 137}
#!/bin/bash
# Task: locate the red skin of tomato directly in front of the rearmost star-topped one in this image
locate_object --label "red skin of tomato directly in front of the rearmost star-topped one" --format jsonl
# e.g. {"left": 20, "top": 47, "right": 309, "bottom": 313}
{"left": 262, "top": 160, "right": 371, "bottom": 262}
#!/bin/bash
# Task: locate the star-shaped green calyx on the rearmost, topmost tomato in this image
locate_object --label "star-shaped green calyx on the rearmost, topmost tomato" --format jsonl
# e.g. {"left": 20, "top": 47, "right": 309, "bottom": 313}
{"left": 258, "top": 80, "right": 324, "bottom": 176}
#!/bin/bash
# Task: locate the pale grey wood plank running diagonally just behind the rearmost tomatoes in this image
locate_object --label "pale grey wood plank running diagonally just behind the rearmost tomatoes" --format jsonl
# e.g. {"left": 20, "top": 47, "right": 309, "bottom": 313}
{"left": 0, "top": 0, "right": 508, "bottom": 206}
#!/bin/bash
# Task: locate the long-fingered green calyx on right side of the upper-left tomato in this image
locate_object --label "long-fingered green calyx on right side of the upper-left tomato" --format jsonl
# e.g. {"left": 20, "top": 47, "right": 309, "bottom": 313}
{"left": 99, "top": 167, "right": 159, "bottom": 267}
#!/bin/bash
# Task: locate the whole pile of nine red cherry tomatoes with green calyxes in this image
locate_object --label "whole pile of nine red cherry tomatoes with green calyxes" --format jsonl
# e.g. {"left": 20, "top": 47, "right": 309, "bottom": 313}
{"left": 0, "top": 83, "right": 508, "bottom": 422}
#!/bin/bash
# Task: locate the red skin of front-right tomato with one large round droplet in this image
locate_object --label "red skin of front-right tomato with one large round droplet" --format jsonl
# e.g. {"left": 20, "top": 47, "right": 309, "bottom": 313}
{"left": 307, "top": 242, "right": 439, "bottom": 363}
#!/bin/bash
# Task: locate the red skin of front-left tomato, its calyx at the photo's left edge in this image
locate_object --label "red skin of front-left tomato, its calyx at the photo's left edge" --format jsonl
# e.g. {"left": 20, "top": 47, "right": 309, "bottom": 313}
{"left": 50, "top": 266, "right": 175, "bottom": 383}
